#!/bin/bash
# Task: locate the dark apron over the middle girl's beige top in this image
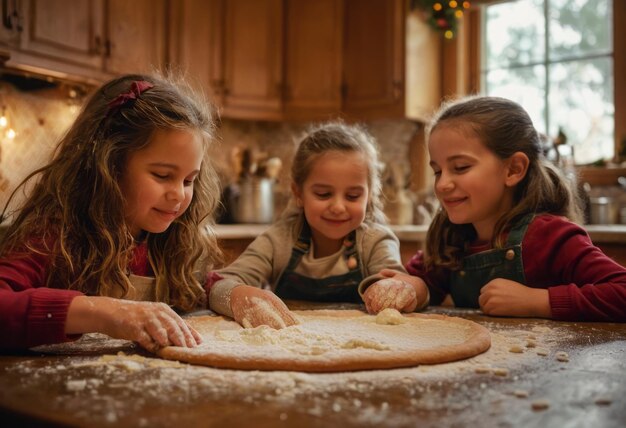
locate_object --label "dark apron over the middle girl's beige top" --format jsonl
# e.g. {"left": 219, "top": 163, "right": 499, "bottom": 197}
{"left": 274, "top": 221, "right": 363, "bottom": 303}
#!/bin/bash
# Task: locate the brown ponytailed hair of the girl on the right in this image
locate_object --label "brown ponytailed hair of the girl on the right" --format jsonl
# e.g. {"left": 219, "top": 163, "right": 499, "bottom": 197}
{"left": 426, "top": 96, "right": 583, "bottom": 270}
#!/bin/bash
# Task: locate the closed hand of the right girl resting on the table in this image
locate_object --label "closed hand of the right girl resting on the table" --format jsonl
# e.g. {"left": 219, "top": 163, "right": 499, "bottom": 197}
{"left": 478, "top": 278, "right": 552, "bottom": 318}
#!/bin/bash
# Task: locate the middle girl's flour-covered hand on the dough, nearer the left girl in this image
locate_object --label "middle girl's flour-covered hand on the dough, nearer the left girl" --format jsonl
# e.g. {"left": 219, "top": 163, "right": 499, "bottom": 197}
{"left": 230, "top": 285, "right": 298, "bottom": 329}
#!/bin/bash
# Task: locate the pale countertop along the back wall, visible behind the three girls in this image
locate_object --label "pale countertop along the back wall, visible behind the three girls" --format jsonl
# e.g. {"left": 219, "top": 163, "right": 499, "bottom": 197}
{"left": 216, "top": 224, "right": 626, "bottom": 244}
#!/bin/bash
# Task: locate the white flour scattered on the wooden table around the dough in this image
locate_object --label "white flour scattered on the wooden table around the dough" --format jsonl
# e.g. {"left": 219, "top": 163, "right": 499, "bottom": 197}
{"left": 0, "top": 322, "right": 568, "bottom": 426}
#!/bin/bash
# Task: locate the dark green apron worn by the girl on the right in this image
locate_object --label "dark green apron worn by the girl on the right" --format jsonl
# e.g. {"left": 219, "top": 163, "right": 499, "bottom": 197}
{"left": 450, "top": 215, "right": 534, "bottom": 308}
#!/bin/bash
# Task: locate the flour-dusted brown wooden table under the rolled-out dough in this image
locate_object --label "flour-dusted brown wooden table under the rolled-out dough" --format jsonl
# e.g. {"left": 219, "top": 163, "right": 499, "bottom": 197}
{"left": 0, "top": 302, "right": 626, "bottom": 428}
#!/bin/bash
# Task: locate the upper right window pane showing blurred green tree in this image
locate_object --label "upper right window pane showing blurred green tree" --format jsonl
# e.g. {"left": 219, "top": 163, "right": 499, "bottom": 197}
{"left": 548, "top": 0, "right": 608, "bottom": 61}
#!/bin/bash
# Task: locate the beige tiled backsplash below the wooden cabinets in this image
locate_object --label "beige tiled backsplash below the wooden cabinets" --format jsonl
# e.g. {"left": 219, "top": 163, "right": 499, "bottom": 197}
{"left": 0, "top": 81, "right": 421, "bottom": 224}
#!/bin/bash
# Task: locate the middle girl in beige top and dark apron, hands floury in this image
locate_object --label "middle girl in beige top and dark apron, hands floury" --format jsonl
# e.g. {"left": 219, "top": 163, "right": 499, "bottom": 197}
{"left": 209, "top": 123, "right": 427, "bottom": 328}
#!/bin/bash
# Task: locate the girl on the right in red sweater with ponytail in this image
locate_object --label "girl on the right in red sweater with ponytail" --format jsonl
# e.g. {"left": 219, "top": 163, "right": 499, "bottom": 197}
{"left": 400, "top": 96, "right": 626, "bottom": 322}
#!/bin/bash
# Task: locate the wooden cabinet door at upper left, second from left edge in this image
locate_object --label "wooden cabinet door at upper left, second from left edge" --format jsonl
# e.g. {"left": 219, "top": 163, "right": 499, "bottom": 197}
{"left": 20, "top": 0, "right": 103, "bottom": 68}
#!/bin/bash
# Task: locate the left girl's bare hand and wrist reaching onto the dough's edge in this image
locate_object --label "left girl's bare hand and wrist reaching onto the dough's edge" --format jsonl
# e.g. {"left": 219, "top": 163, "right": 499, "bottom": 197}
{"left": 66, "top": 296, "right": 202, "bottom": 352}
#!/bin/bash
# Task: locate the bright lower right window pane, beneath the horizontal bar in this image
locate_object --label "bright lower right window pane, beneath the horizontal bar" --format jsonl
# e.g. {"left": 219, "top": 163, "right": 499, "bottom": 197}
{"left": 549, "top": 58, "right": 614, "bottom": 164}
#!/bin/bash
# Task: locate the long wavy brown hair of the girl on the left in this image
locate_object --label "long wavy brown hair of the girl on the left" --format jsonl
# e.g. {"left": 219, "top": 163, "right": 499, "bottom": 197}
{"left": 0, "top": 74, "right": 221, "bottom": 311}
